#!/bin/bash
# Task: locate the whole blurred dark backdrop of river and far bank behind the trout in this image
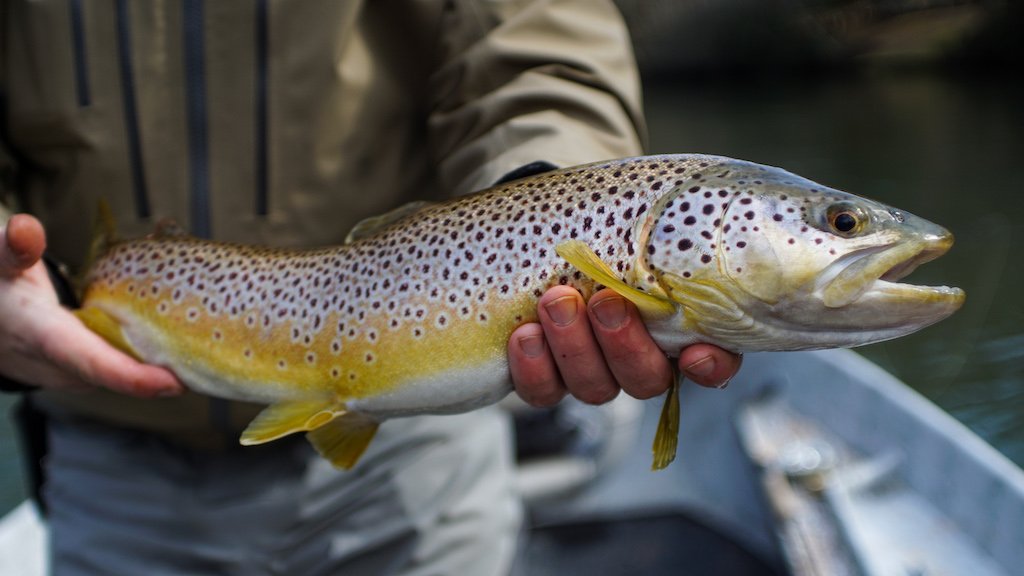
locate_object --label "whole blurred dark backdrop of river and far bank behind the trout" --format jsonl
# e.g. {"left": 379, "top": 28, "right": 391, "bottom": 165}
{"left": 0, "top": 0, "right": 1024, "bottom": 513}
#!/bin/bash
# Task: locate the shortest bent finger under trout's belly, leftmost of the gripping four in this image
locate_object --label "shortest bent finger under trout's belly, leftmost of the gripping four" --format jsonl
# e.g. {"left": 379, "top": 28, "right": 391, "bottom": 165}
{"left": 508, "top": 324, "right": 565, "bottom": 408}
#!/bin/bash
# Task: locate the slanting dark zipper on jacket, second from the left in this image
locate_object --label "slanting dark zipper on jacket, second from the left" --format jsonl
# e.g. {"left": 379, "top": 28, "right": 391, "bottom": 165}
{"left": 115, "top": 0, "right": 151, "bottom": 219}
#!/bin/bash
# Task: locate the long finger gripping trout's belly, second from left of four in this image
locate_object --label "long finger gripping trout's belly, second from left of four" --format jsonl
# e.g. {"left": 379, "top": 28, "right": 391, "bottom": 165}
{"left": 538, "top": 286, "right": 618, "bottom": 404}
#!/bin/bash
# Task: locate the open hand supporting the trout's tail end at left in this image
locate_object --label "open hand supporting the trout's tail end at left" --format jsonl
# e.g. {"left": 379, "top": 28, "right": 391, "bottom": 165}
{"left": 0, "top": 214, "right": 183, "bottom": 397}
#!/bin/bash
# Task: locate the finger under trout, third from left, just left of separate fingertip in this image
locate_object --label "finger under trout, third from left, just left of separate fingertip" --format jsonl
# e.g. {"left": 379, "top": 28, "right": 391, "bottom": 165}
{"left": 588, "top": 289, "right": 672, "bottom": 399}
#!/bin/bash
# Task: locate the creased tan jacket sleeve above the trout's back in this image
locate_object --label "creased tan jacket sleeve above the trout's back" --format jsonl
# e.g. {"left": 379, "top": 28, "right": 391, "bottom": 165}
{"left": 429, "top": 0, "right": 645, "bottom": 194}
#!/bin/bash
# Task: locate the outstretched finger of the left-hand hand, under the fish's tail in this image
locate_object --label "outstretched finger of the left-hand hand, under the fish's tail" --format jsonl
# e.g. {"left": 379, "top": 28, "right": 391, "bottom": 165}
{"left": 40, "top": 313, "right": 183, "bottom": 397}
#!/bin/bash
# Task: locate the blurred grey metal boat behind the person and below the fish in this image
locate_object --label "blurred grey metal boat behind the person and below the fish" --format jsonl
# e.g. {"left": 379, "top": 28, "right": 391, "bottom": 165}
{"left": 0, "top": 351, "right": 1024, "bottom": 576}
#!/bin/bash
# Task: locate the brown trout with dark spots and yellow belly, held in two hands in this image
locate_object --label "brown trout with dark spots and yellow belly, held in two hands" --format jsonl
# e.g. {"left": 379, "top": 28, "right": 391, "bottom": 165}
{"left": 77, "top": 155, "right": 965, "bottom": 467}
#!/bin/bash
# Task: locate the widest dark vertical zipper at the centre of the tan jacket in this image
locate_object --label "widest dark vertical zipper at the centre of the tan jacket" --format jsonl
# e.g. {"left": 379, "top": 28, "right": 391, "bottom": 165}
{"left": 181, "top": 0, "right": 212, "bottom": 238}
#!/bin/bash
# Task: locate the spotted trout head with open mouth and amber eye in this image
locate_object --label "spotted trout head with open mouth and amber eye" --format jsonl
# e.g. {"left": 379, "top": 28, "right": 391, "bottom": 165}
{"left": 641, "top": 159, "right": 965, "bottom": 351}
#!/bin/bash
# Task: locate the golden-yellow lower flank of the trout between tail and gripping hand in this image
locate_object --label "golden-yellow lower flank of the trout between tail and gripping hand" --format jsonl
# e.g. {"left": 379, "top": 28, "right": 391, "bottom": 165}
{"left": 82, "top": 281, "right": 536, "bottom": 400}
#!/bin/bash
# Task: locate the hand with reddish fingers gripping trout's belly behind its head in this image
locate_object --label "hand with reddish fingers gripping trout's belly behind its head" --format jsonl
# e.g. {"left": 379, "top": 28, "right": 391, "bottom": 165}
{"left": 508, "top": 286, "right": 742, "bottom": 407}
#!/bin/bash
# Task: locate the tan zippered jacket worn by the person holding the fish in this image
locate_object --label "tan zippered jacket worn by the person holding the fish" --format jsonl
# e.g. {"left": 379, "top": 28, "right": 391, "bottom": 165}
{"left": 0, "top": 0, "right": 643, "bottom": 439}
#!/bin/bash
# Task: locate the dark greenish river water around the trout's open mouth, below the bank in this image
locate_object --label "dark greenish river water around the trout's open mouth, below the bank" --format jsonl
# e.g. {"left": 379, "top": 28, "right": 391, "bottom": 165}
{"left": 0, "top": 74, "right": 1024, "bottom": 512}
